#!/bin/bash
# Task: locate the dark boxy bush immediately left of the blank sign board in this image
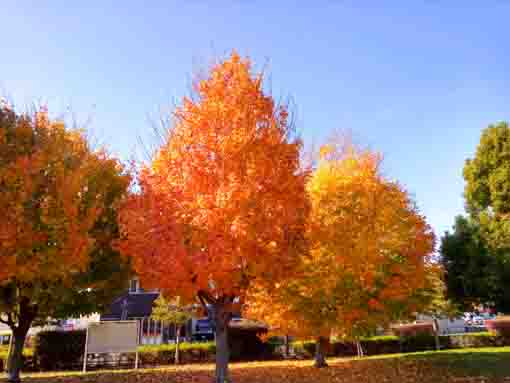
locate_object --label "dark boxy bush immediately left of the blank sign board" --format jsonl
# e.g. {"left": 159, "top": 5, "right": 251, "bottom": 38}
{"left": 34, "top": 330, "right": 86, "bottom": 371}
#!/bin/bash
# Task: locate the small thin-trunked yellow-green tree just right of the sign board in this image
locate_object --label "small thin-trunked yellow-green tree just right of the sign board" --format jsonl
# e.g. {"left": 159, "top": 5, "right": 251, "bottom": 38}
{"left": 151, "top": 294, "right": 194, "bottom": 364}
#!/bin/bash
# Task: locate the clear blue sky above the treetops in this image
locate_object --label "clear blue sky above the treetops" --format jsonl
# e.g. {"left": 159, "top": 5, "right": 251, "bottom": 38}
{"left": 0, "top": 0, "right": 510, "bottom": 238}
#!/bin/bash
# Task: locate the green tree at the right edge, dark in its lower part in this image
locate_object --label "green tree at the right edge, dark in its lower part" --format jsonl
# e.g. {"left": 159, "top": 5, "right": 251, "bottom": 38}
{"left": 441, "top": 122, "right": 510, "bottom": 312}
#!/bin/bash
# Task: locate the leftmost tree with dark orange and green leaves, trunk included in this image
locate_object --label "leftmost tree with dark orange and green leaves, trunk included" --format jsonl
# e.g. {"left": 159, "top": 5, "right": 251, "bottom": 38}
{"left": 0, "top": 104, "right": 130, "bottom": 382}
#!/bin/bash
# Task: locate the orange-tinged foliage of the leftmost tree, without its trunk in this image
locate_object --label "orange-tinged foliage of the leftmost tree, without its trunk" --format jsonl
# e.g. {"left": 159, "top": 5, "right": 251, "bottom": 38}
{"left": 0, "top": 105, "right": 130, "bottom": 286}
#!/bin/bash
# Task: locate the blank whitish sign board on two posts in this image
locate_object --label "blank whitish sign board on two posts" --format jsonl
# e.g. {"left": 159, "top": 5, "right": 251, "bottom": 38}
{"left": 83, "top": 321, "right": 140, "bottom": 371}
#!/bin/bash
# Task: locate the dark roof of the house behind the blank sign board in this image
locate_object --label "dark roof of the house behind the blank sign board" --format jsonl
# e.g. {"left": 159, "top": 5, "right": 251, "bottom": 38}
{"left": 101, "top": 292, "right": 159, "bottom": 320}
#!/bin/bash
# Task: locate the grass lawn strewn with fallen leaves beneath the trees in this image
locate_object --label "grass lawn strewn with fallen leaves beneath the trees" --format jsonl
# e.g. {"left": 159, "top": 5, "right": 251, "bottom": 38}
{"left": 7, "top": 347, "right": 510, "bottom": 383}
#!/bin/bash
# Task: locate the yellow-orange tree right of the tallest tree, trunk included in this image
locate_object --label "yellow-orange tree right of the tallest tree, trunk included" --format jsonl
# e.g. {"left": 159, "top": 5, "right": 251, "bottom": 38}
{"left": 248, "top": 145, "right": 435, "bottom": 367}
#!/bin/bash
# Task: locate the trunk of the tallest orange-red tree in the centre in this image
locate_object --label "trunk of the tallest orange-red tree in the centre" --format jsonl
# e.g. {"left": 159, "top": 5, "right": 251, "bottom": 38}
{"left": 214, "top": 304, "right": 231, "bottom": 383}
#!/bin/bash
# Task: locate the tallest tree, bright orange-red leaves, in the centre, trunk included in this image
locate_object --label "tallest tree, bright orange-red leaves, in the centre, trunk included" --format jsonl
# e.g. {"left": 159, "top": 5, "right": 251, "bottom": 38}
{"left": 119, "top": 53, "right": 307, "bottom": 383}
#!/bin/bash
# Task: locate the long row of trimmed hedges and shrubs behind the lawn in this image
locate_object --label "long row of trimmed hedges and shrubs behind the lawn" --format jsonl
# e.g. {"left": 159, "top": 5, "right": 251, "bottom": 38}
{"left": 0, "top": 331, "right": 510, "bottom": 371}
